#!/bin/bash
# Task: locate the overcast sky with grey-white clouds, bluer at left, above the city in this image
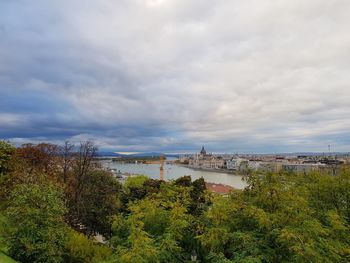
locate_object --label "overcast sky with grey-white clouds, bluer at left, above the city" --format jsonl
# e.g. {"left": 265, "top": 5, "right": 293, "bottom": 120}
{"left": 0, "top": 0, "right": 350, "bottom": 152}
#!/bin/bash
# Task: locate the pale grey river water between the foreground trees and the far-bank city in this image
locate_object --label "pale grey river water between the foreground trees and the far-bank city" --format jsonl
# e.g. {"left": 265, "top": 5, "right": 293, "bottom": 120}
{"left": 102, "top": 160, "right": 247, "bottom": 189}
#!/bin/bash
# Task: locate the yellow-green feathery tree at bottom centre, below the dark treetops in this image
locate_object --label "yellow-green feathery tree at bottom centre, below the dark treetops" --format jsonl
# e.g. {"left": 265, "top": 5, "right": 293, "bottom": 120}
{"left": 111, "top": 180, "right": 200, "bottom": 262}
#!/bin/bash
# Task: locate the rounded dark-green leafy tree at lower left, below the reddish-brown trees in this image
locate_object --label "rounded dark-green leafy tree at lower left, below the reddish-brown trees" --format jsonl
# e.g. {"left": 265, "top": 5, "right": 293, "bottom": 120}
{"left": 6, "top": 184, "right": 67, "bottom": 263}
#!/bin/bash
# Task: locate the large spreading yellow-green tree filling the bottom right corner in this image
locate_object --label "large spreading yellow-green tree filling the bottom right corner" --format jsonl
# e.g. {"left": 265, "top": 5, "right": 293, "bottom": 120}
{"left": 199, "top": 173, "right": 350, "bottom": 262}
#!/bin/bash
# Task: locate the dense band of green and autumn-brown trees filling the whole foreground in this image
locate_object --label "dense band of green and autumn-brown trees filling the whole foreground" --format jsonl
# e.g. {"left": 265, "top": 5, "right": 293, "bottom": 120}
{"left": 0, "top": 142, "right": 350, "bottom": 263}
